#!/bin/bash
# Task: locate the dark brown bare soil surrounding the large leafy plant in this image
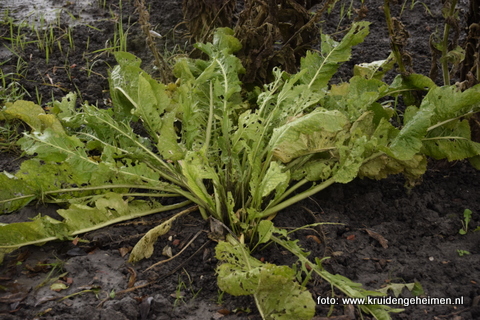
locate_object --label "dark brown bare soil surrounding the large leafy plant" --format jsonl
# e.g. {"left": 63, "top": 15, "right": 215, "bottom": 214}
{"left": 0, "top": 0, "right": 480, "bottom": 320}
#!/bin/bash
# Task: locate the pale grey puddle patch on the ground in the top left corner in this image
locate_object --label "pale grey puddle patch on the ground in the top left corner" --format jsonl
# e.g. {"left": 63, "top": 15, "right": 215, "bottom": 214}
{"left": 0, "top": 0, "right": 101, "bottom": 27}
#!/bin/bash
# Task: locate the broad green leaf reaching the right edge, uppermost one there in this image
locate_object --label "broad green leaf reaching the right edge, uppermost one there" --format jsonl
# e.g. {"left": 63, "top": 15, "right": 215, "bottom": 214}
{"left": 387, "top": 86, "right": 480, "bottom": 161}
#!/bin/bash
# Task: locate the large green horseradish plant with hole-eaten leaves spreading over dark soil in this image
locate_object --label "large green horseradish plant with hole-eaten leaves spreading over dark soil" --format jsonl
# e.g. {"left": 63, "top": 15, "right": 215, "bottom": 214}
{"left": 0, "top": 22, "right": 480, "bottom": 319}
